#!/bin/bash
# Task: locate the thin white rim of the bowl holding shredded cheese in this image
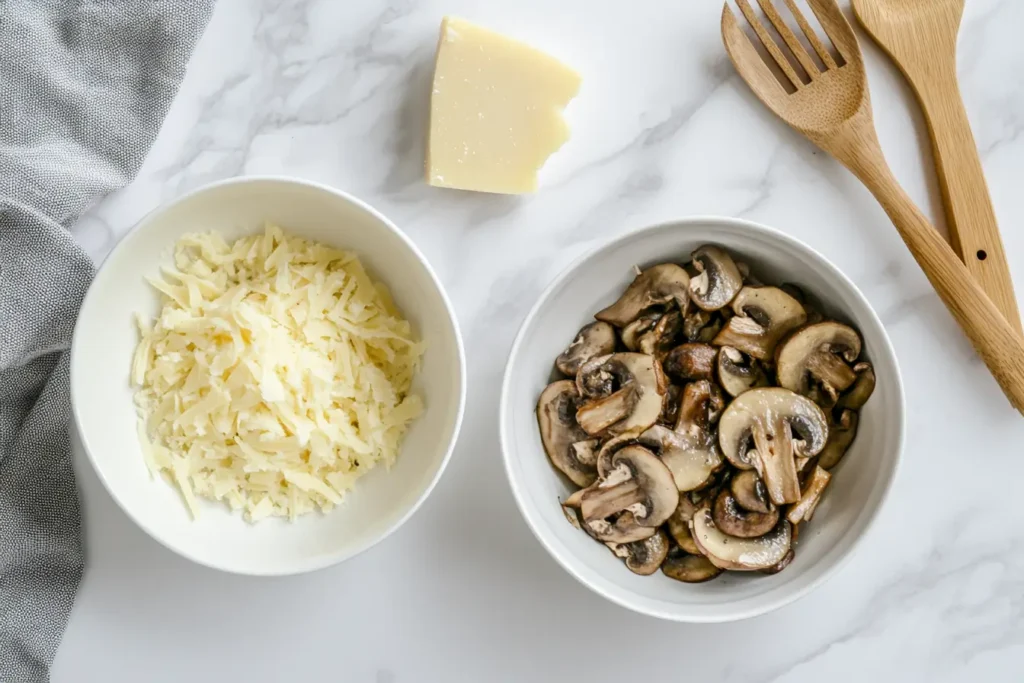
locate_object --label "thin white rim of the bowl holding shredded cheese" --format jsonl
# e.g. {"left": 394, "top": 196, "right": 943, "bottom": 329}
{"left": 69, "top": 174, "right": 468, "bottom": 577}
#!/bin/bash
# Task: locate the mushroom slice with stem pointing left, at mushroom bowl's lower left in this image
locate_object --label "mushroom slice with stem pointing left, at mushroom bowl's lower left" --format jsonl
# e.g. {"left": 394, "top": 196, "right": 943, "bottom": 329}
{"left": 581, "top": 445, "right": 679, "bottom": 526}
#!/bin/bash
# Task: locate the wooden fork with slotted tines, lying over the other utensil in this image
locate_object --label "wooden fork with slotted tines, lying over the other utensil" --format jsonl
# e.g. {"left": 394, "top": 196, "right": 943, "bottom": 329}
{"left": 722, "top": 0, "right": 1024, "bottom": 413}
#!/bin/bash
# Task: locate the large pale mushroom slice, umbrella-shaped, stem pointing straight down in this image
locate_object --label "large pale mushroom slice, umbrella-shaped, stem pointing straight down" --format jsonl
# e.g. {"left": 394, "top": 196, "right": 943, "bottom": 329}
{"left": 718, "top": 387, "right": 828, "bottom": 505}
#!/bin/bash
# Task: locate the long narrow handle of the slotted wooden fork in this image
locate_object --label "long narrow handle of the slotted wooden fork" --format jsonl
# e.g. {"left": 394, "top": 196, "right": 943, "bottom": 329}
{"left": 841, "top": 148, "right": 1024, "bottom": 414}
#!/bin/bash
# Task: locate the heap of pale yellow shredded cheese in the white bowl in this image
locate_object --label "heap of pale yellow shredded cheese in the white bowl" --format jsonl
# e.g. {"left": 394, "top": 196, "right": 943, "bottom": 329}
{"left": 131, "top": 225, "right": 423, "bottom": 521}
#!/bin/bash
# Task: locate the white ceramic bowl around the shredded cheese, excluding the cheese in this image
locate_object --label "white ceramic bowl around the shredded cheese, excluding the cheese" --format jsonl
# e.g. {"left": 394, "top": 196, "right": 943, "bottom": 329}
{"left": 71, "top": 177, "right": 466, "bottom": 574}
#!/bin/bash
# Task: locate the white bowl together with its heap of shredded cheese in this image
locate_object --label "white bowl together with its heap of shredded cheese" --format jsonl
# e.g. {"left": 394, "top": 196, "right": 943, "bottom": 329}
{"left": 71, "top": 177, "right": 466, "bottom": 574}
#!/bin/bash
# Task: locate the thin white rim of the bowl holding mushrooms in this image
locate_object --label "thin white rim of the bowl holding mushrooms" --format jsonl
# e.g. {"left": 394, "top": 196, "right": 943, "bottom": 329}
{"left": 498, "top": 215, "right": 906, "bottom": 624}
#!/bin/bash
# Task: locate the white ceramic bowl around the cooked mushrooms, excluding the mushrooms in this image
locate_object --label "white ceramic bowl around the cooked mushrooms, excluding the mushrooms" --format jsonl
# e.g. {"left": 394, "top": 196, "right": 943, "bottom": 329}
{"left": 501, "top": 218, "right": 904, "bottom": 623}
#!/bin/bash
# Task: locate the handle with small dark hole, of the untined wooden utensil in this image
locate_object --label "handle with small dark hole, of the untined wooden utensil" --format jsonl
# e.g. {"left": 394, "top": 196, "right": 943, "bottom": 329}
{"left": 918, "top": 66, "right": 1021, "bottom": 331}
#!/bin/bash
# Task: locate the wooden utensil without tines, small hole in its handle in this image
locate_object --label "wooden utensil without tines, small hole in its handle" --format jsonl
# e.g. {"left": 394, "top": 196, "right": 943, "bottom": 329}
{"left": 853, "top": 0, "right": 1021, "bottom": 330}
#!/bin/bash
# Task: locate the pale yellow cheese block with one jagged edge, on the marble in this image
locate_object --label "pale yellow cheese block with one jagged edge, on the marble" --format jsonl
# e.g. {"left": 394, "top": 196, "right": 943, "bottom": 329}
{"left": 427, "top": 16, "right": 581, "bottom": 195}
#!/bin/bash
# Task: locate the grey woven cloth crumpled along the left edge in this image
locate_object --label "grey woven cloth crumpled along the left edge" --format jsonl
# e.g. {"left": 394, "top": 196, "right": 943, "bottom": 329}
{"left": 0, "top": 0, "right": 213, "bottom": 683}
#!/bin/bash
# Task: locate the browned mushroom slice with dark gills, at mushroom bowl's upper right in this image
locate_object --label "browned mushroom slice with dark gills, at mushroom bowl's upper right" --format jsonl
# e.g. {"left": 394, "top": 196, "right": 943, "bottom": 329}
{"left": 775, "top": 322, "right": 860, "bottom": 404}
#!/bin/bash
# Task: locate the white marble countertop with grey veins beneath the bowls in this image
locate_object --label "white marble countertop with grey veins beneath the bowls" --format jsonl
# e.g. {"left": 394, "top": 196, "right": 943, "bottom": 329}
{"left": 53, "top": 0, "right": 1024, "bottom": 683}
